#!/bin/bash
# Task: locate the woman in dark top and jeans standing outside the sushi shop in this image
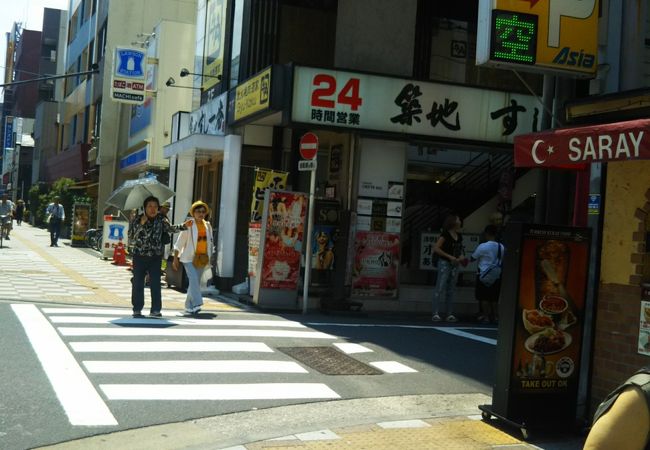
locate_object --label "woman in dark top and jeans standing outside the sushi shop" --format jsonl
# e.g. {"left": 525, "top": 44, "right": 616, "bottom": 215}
{"left": 431, "top": 214, "right": 467, "bottom": 322}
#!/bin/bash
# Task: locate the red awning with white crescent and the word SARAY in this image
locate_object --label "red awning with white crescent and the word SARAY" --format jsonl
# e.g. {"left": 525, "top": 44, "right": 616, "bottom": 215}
{"left": 515, "top": 119, "right": 650, "bottom": 169}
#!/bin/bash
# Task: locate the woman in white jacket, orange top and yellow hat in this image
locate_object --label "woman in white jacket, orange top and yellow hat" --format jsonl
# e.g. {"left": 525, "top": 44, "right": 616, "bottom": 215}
{"left": 172, "top": 200, "right": 213, "bottom": 314}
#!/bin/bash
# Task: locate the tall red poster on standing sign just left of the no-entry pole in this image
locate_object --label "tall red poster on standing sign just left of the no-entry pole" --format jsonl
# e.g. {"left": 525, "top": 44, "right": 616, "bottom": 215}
{"left": 260, "top": 191, "right": 307, "bottom": 290}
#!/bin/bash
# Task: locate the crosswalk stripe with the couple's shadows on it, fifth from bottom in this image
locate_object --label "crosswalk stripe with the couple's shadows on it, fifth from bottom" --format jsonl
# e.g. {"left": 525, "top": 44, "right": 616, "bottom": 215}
{"left": 50, "top": 316, "right": 307, "bottom": 328}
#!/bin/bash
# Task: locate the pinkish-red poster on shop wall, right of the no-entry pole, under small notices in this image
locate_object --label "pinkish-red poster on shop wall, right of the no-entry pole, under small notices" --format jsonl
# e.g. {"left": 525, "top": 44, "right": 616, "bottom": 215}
{"left": 352, "top": 231, "right": 399, "bottom": 297}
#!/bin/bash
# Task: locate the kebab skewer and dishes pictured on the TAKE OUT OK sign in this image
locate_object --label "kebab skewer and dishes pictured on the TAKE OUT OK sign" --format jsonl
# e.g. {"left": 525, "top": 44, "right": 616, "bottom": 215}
{"left": 522, "top": 241, "right": 577, "bottom": 355}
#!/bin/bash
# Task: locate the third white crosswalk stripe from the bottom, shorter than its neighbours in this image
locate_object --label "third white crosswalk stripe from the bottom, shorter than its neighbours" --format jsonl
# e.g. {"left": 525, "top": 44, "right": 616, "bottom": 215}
{"left": 69, "top": 341, "right": 273, "bottom": 353}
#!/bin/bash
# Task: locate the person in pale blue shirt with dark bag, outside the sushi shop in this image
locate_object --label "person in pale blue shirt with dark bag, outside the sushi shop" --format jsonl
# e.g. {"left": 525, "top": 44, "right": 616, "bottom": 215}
{"left": 471, "top": 225, "right": 505, "bottom": 323}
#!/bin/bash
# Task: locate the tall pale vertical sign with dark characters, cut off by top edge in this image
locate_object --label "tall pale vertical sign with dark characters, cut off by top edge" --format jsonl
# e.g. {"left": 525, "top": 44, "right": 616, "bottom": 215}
{"left": 201, "top": 0, "right": 227, "bottom": 91}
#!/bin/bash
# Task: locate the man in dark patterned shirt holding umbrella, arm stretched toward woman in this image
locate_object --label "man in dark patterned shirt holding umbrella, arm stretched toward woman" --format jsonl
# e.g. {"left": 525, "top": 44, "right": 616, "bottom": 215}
{"left": 129, "top": 197, "right": 185, "bottom": 317}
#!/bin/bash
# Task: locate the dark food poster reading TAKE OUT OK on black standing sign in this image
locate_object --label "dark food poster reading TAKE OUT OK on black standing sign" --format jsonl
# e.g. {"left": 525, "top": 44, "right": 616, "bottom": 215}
{"left": 510, "top": 225, "right": 590, "bottom": 400}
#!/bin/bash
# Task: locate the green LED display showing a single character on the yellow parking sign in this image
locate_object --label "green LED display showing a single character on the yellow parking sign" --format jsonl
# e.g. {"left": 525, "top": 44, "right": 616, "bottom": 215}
{"left": 490, "top": 9, "right": 537, "bottom": 65}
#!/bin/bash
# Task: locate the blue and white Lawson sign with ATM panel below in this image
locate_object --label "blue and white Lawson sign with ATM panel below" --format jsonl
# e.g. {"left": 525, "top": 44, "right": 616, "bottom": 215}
{"left": 111, "top": 47, "right": 147, "bottom": 105}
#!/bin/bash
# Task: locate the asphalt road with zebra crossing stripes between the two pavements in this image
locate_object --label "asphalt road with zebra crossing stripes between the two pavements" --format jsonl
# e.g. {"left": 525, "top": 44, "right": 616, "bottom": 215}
{"left": 0, "top": 300, "right": 496, "bottom": 449}
